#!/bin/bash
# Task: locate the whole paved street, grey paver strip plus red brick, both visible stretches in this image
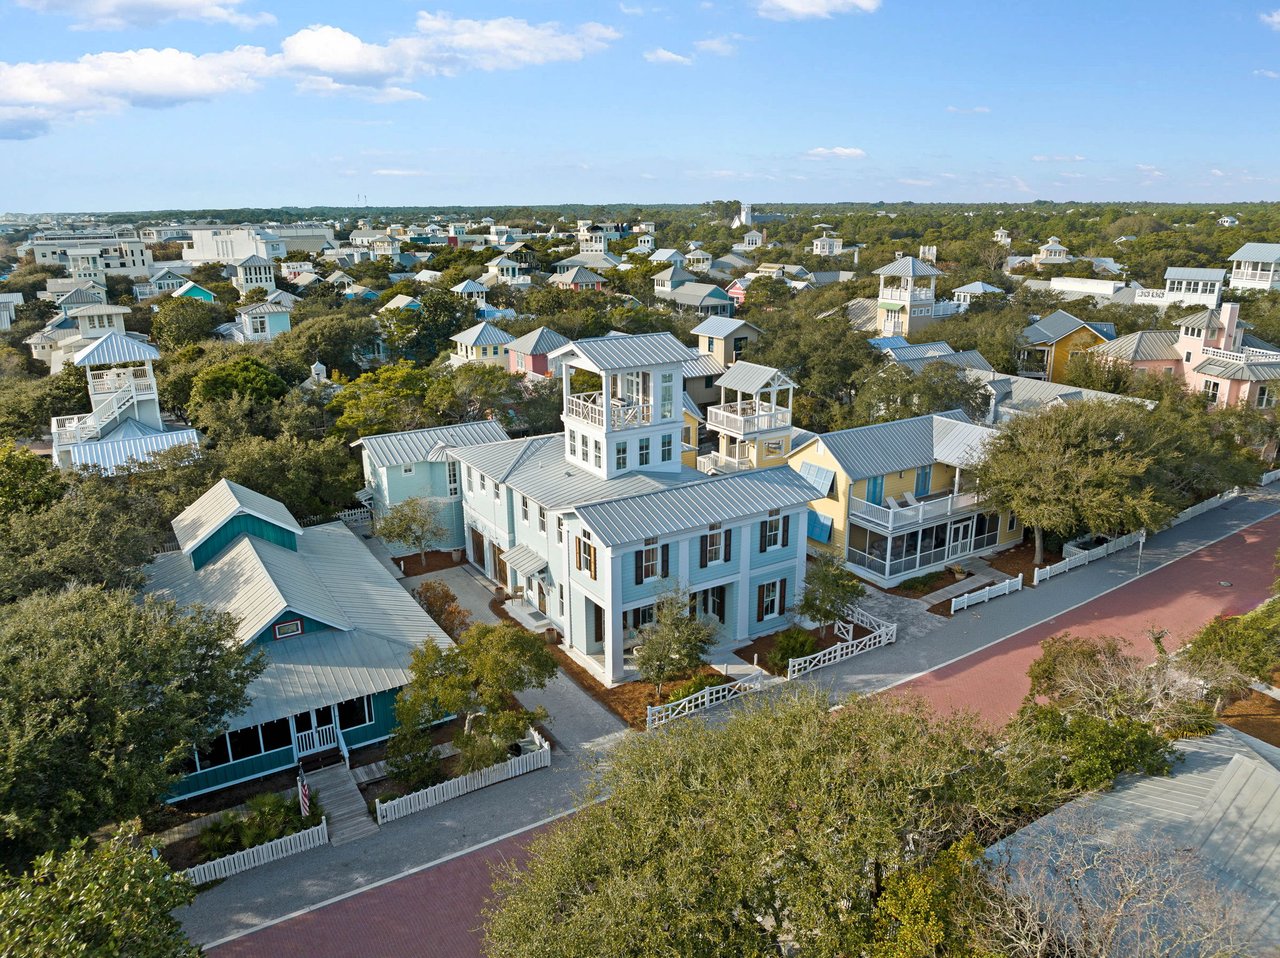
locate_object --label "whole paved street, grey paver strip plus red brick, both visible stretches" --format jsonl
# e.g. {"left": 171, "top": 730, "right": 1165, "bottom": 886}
{"left": 192, "top": 491, "right": 1280, "bottom": 958}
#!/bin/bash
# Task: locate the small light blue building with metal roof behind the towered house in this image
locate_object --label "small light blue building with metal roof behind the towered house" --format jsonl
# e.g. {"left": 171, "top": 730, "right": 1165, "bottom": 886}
{"left": 351, "top": 419, "right": 509, "bottom": 549}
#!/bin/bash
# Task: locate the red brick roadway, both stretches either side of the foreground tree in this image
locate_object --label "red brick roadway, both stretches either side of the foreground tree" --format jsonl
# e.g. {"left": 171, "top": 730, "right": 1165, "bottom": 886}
{"left": 210, "top": 516, "right": 1280, "bottom": 958}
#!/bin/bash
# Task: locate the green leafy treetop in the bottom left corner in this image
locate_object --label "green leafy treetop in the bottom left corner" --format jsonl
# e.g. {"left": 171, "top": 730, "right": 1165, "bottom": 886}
{"left": 0, "top": 827, "right": 200, "bottom": 958}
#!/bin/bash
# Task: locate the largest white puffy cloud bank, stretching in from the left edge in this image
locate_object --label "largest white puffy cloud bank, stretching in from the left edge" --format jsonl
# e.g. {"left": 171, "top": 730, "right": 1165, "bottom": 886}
{"left": 0, "top": 11, "right": 620, "bottom": 140}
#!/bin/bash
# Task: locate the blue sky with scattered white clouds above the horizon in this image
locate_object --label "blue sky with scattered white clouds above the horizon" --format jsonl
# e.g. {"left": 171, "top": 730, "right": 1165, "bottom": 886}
{"left": 0, "top": 0, "right": 1280, "bottom": 211}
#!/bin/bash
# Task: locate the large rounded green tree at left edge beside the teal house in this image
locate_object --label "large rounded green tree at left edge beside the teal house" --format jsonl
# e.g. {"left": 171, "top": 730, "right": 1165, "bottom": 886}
{"left": 0, "top": 587, "right": 264, "bottom": 868}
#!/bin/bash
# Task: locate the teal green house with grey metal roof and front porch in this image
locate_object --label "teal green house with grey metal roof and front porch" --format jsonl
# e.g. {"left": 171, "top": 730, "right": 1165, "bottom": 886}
{"left": 145, "top": 479, "right": 449, "bottom": 800}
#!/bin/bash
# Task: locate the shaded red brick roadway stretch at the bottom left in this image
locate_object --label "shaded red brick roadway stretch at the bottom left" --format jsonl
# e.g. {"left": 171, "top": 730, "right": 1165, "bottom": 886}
{"left": 206, "top": 825, "right": 548, "bottom": 958}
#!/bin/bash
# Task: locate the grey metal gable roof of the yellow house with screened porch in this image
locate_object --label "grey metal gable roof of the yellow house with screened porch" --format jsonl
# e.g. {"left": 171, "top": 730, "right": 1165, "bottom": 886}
{"left": 788, "top": 410, "right": 996, "bottom": 482}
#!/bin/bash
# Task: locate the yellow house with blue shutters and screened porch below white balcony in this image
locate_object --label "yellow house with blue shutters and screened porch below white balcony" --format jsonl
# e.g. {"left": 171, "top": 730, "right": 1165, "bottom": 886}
{"left": 787, "top": 410, "right": 1023, "bottom": 587}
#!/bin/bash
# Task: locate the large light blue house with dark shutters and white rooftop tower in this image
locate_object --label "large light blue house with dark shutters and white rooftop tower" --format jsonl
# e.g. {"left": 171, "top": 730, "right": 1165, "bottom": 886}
{"left": 448, "top": 333, "right": 814, "bottom": 684}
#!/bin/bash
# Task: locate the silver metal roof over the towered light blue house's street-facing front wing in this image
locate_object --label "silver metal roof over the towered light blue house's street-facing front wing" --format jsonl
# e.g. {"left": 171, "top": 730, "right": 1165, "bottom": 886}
{"left": 576, "top": 466, "right": 814, "bottom": 546}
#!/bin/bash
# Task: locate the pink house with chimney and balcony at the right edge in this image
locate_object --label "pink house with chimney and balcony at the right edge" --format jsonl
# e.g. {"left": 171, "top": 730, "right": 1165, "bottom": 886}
{"left": 1092, "top": 302, "right": 1280, "bottom": 409}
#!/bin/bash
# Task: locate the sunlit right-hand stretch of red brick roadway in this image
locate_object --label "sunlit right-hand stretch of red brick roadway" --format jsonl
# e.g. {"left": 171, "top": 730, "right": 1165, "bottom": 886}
{"left": 899, "top": 516, "right": 1280, "bottom": 725}
